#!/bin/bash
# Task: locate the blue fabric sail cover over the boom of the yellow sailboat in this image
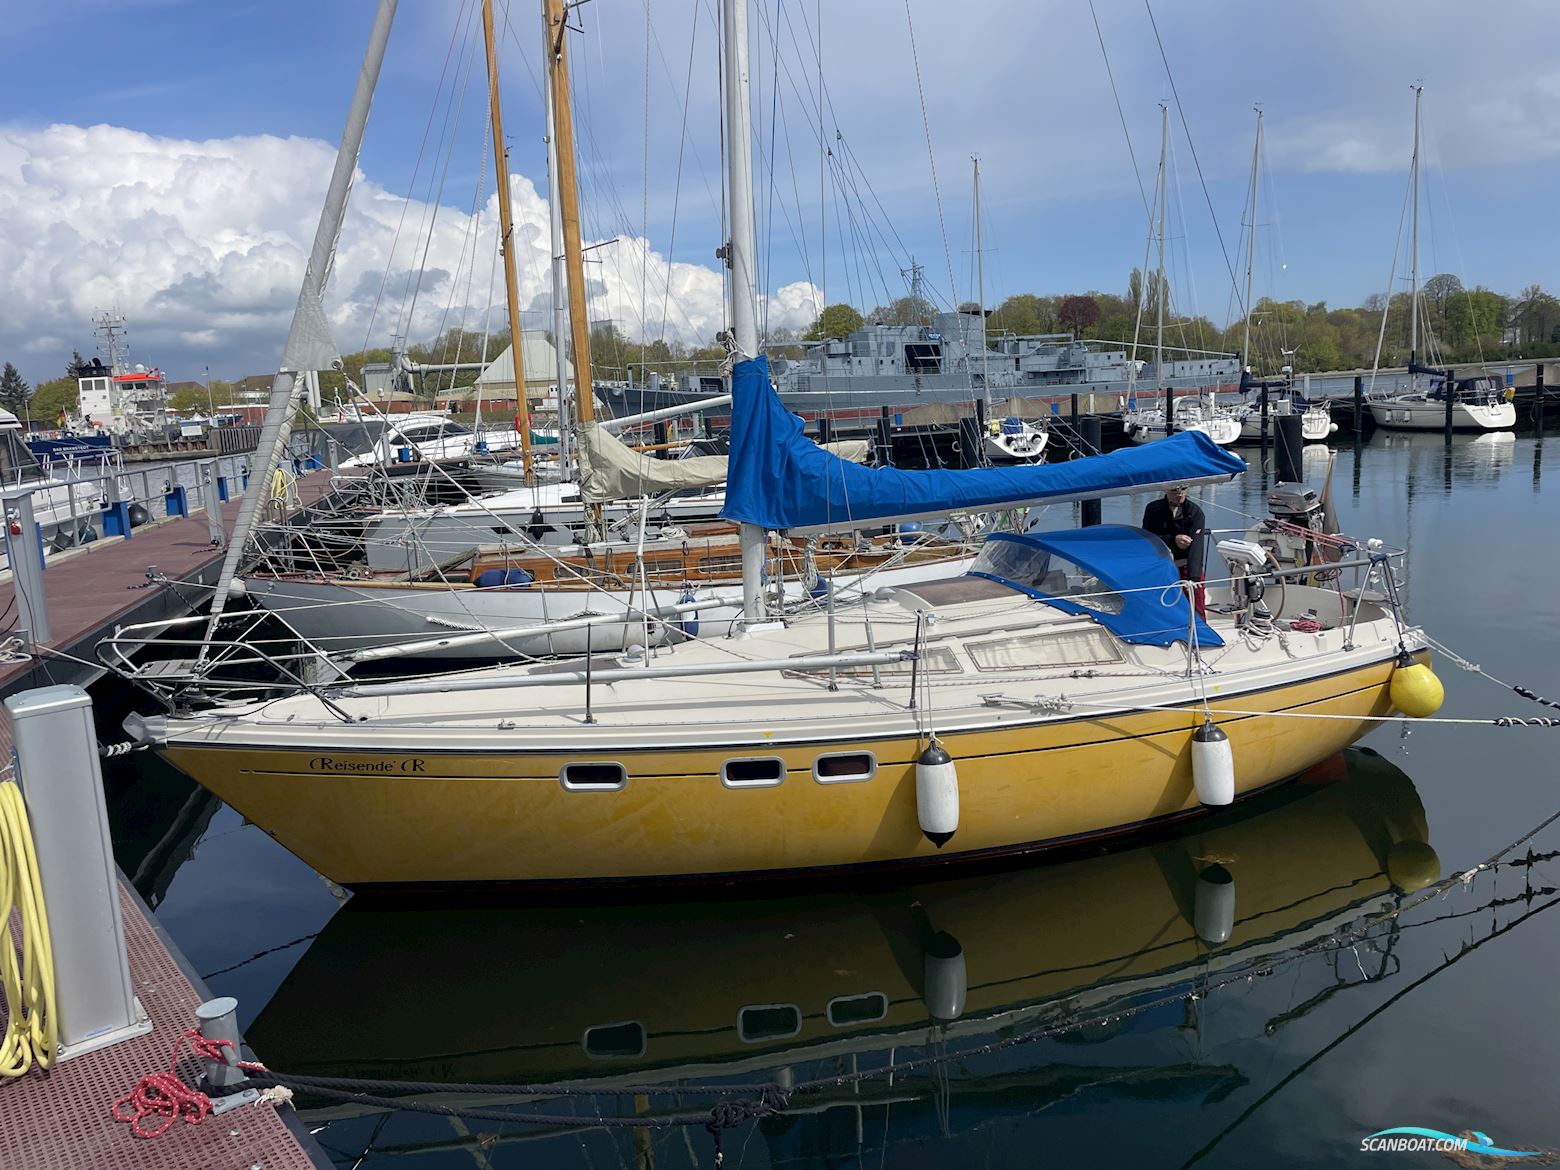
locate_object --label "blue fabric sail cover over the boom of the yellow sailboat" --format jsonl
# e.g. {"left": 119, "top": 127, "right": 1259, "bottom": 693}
{"left": 721, "top": 357, "right": 1246, "bottom": 532}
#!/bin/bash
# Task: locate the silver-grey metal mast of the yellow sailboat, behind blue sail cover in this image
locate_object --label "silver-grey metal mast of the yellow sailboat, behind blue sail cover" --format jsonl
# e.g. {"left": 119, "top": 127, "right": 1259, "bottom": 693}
{"left": 721, "top": 0, "right": 768, "bottom": 624}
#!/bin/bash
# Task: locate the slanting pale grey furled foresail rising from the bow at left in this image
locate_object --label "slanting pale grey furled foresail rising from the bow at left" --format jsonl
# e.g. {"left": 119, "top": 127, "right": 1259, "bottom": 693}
{"left": 206, "top": 0, "right": 396, "bottom": 640}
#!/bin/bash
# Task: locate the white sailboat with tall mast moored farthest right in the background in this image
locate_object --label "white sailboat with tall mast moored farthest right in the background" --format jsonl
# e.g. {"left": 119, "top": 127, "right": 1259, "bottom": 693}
{"left": 1368, "top": 86, "right": 1516, "bottom": 431}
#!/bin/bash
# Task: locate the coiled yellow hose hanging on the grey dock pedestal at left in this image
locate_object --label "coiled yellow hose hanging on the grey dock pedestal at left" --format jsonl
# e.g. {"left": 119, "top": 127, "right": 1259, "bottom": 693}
{"left": 0, "top": 780, "right": 59, "bottom": 1076}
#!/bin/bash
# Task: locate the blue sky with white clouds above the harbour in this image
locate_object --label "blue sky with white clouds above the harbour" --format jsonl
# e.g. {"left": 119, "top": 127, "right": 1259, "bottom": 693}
{"left": 0, "top": 0, "right": 1560, "bottom": 384}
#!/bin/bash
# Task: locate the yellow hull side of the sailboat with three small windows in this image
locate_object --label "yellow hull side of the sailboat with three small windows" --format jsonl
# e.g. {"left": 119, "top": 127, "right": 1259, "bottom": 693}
{"left": 162, "top": 660, "right": 1393, "bottom": 888}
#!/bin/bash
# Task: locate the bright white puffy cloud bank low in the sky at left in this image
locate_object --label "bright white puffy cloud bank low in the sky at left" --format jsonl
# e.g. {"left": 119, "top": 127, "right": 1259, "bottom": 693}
{"left": 0, "top": 125, "right": 817, "bottom": 381}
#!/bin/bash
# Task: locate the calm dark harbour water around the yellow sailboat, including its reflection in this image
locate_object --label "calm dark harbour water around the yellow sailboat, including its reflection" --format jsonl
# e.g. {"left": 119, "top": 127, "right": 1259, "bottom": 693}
{"left": 115, "top": 432, "right": 1560, "bottom": 1170}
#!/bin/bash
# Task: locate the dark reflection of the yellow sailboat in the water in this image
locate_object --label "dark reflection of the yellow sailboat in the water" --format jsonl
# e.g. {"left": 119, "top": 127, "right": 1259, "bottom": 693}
{"left": 248, "top": 749, "right": 1440, "bottom": 1166}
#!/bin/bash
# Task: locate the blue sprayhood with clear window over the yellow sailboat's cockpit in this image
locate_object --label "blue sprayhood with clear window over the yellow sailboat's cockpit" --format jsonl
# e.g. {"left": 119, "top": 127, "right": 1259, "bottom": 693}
{"left": 970, "top": 524, "right": 1225, "bottom": 646}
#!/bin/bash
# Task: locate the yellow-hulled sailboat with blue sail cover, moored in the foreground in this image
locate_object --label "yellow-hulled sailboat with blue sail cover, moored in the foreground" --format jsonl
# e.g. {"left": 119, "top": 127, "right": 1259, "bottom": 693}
{"left": 105, "top": 0, "right": 1438, "bottom": 886}
